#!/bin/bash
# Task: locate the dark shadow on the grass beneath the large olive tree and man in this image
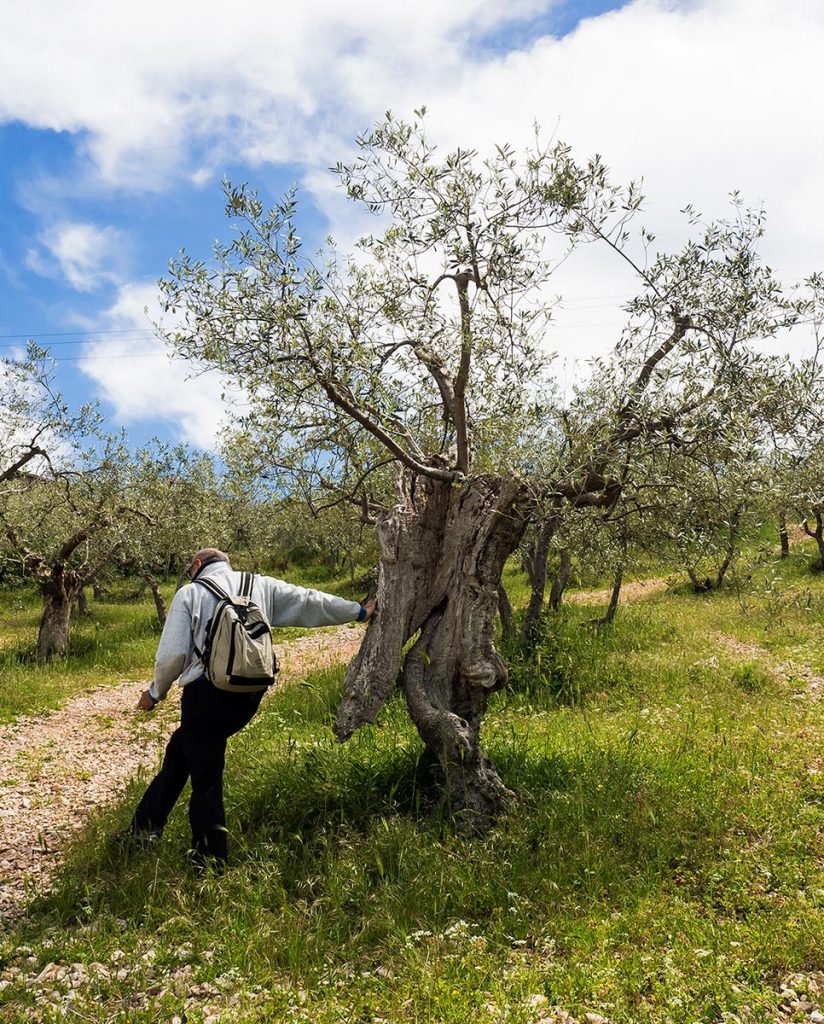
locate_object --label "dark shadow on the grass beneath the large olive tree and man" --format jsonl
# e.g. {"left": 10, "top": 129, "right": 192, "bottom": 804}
{"left": 32, "top": 720, "right": 729, "bottom": 932}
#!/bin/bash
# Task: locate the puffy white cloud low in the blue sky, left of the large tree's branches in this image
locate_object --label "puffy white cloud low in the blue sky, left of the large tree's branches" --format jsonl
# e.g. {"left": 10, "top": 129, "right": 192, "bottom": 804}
{"left": 80, "top": 283, "right": 234, "bottom": 449}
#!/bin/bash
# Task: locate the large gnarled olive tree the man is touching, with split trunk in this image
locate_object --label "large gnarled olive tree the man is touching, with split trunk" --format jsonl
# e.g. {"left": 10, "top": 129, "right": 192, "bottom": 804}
{"left": 162, "top": 118, "right": 814, "bottom": 820}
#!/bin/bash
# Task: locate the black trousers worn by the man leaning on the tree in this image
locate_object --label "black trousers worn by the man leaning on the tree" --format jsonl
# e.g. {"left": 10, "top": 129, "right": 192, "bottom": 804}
{"left": 132, "top": 676, "right": 265, "bottom": 860}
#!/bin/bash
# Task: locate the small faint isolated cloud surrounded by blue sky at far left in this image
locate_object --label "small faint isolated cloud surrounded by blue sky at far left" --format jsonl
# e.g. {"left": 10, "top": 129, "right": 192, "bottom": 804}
{"left": 27, "top": 221, "right": 125, "bottom": 292}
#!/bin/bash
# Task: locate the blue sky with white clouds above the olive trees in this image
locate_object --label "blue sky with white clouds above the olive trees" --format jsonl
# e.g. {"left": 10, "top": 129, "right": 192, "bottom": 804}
{"left": 0, "top": 0, "right": 824, "bottom": 446}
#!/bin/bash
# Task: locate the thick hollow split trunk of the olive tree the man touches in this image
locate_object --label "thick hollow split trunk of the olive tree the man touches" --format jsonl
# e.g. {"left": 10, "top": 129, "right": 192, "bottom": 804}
{"left": 335, "top": 474, "right": 533, "bottom": 825}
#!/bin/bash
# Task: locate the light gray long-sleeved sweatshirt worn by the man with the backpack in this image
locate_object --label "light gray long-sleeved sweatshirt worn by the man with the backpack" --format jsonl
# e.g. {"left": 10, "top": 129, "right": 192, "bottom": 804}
{"left": 148, "top": 562, "right": 360, "bottom": 700}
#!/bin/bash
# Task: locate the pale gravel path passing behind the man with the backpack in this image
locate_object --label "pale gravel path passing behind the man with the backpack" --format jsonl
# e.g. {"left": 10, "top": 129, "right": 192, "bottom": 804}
{"left": 0, "top": 626, "right": 363, "bottom": 921}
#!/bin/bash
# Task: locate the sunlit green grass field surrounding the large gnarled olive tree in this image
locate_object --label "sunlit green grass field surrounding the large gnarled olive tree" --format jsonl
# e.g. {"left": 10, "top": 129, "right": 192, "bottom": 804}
{"left": 0, "top": 544, "right": 824, "bottom": 1024}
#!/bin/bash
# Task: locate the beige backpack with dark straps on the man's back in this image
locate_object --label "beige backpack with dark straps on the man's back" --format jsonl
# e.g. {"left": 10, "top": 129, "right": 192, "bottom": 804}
{"left": 194, "top": 572, "right": 277, "bottom": 693}
